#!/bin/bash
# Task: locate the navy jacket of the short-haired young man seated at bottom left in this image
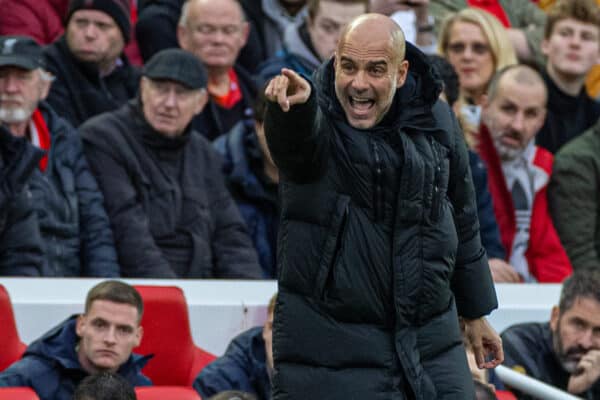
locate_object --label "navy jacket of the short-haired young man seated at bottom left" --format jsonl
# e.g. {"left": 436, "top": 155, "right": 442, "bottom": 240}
{"left": 0, "top": 315, "right": 152, "bottom": 400}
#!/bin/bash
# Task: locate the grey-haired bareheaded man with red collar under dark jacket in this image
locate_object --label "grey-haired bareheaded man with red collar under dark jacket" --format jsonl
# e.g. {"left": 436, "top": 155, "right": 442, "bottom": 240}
{"left": 177, "top": 0, "right": 256, "bottom": 139}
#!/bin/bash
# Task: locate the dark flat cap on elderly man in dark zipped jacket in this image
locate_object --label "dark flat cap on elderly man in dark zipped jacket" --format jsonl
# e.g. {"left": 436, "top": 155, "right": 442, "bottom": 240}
{"left": 142, "top": 48, "right": 208, "bottom": 90}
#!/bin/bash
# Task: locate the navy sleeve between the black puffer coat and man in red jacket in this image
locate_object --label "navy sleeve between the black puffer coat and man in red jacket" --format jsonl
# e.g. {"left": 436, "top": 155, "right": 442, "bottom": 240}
{"left": 469, "top": 150, "right": 506, "bottom": 260}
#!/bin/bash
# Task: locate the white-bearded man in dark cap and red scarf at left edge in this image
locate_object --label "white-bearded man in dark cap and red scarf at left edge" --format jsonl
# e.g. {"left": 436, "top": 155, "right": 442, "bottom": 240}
{"left": 0, "top": 36, "right": 119, "bottom": 277}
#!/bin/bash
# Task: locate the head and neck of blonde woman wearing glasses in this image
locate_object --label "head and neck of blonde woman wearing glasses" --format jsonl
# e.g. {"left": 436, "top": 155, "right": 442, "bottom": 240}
{"left": 438, "top": 8, "right": 517, "bottom": 140}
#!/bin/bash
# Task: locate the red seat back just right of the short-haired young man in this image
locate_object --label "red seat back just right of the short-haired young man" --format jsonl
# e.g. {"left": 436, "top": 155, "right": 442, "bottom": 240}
{"left": 134, "top": 285, "right": 216, "bottom": 386}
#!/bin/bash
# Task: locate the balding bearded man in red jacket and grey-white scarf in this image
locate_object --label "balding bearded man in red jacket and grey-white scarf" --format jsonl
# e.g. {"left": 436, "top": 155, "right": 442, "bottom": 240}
{"left": 478, "top": 65, "right": 572, "bottom": 282}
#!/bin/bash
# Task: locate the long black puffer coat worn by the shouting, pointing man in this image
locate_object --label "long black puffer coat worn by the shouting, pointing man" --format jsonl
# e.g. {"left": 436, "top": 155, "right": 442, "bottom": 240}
{"left": 265, "top": 44, "right": 497, "bottom": 400}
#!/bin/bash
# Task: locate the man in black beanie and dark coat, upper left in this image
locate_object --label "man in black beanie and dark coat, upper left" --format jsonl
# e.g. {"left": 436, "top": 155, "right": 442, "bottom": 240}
{"left": 44, "top": 0, "right": 139, "bottom": 127}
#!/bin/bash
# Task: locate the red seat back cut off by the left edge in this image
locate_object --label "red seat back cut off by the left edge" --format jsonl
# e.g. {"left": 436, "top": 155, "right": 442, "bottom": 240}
{"left": 0, "top": 285, "right": 27, "bottom": 371}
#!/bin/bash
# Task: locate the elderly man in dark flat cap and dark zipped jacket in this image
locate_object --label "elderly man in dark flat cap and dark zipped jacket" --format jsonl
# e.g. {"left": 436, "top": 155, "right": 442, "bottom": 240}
{"left": 81, "top": 49, "right": 261, "bottom": 278}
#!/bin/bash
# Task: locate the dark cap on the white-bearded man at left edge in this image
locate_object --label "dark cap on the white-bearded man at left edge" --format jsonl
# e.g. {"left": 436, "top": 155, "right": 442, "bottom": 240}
{"left": 0, "top": 36, "right": 44, "bottom": 70}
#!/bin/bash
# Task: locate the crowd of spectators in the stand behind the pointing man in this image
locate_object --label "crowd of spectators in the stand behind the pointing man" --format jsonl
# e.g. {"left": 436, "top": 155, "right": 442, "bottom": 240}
{"left": 0, "top": 0, "right": 600, "bottom": 399}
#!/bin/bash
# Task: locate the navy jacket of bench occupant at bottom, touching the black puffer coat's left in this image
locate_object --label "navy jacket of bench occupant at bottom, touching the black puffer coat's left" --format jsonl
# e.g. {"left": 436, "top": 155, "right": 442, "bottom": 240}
{"left": 194, "top": 326, "right": 271, "bottom": 400}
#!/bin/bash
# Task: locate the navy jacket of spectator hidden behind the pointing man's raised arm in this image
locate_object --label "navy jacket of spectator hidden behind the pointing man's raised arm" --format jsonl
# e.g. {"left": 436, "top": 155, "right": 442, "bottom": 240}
{"left": 213, "top": 120, "right": 279, "bottom": 279}
